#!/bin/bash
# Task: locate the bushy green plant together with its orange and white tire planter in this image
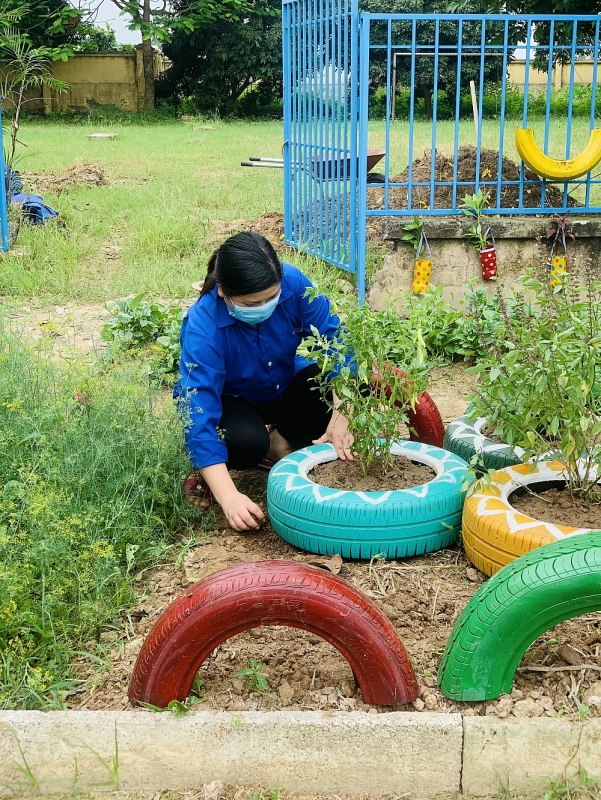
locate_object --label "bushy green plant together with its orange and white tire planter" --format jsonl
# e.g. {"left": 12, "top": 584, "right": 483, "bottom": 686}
{"left": 463, "top": 274, "right": 601, "bottom": 574}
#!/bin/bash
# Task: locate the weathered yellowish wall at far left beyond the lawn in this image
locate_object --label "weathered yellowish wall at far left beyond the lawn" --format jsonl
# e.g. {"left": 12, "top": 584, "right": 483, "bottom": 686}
{"left": 5, "top": 45, "right": 169, "bottom": 114}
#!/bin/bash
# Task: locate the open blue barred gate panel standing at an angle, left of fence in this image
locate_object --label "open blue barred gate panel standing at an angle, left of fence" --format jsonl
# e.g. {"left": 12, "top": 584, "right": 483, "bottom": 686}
{"left": 282, "top": 0, "right": 362, "bottom": 291}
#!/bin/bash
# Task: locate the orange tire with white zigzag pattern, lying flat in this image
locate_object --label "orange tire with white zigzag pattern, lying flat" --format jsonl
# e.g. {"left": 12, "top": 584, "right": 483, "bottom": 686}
{"left": 462, "top": 461, "right": 590, "bottom": 575}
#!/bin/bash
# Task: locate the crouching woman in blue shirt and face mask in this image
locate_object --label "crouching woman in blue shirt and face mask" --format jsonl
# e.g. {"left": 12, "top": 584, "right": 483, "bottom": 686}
{"left": 175, "top": 233, "right": 353, "bottom": 530}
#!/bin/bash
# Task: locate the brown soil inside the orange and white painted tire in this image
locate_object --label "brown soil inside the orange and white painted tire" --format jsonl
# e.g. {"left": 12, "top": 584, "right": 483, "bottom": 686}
{"left": 509, "top": 487, "right": 601, "bottom": 530}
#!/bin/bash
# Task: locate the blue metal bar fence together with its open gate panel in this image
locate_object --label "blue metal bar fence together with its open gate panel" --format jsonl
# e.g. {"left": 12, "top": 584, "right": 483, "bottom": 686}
{"left": 283, "top": 10, "right": 601, "bottom": 299}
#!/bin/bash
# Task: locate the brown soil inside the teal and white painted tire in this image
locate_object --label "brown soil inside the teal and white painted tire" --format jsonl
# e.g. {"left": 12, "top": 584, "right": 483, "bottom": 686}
{"left": 309, "top": 456, "right": 436, "bottom": 492}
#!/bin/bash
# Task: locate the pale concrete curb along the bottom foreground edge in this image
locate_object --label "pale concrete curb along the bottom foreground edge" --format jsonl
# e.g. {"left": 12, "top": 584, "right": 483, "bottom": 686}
{"left": 0, "top": 711, "right": 601, "bottom": 798}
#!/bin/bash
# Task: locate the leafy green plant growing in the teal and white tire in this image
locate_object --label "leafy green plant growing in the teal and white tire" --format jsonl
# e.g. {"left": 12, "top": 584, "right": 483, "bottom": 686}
{"left": 299, "top": 294, "right": 428, "bottom": 474}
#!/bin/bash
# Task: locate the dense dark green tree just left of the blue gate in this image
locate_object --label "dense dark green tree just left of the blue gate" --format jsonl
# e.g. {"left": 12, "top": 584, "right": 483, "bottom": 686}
{"left": 160, "top": 0, "right": 282, "bottom": 116}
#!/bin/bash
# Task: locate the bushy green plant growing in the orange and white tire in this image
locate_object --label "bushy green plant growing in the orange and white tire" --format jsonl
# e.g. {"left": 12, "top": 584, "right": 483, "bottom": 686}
{"left": 469, "top": 274, "right": 601, "bottom": 501}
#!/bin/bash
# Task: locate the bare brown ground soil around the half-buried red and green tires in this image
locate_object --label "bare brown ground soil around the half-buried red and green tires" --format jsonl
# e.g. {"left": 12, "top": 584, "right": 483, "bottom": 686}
{"left": 68, "top": 364, "right": 601, "bottom": 718}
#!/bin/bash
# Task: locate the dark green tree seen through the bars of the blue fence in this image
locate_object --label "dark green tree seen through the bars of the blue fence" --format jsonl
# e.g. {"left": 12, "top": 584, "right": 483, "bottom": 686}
{"left": 361, "top": 0, "right": 510, "bottom": 119}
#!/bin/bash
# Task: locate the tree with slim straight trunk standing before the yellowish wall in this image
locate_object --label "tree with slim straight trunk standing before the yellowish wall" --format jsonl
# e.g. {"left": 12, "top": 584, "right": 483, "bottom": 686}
{"left": 76, "top": 0, "right": 248, "bottom": 109}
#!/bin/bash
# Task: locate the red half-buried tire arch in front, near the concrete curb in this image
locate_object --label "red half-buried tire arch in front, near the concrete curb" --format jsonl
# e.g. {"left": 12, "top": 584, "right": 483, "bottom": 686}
{"left": 128, "top": 561, "right": 419, "bottom": 708}
